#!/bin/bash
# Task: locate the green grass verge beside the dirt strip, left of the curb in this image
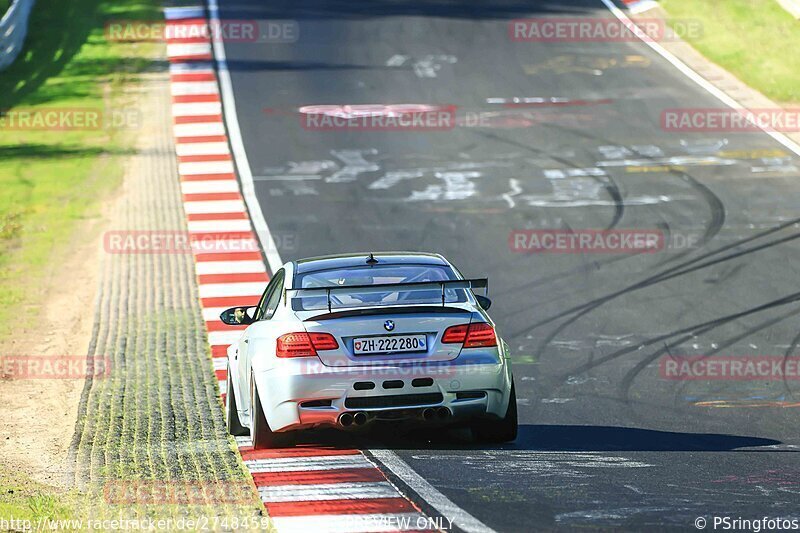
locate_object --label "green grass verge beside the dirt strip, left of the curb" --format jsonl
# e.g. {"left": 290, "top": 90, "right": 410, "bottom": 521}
{"left": 0, "top": 0, "right": 160, "bottom": 336}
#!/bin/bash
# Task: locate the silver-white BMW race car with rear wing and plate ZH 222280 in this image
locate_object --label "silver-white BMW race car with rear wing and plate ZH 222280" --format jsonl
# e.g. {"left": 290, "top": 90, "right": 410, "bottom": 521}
{"left": 220, "top": 252, "right": 517, "bottom": 449}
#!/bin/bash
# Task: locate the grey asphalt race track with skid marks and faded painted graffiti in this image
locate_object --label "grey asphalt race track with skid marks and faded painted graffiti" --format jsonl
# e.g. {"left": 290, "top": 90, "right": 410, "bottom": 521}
{"left": 220, "top": 0, "right": 800, "bottom": 531}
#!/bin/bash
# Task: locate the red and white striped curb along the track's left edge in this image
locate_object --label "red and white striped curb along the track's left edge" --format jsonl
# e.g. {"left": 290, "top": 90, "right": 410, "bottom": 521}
{"left": 165, "top": 6, "right": 435, "bottom": 532}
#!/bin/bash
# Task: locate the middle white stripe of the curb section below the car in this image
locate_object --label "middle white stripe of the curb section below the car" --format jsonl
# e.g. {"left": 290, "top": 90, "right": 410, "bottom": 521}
{"left": 258, "top": 481, "right": 398, "bottom": 503}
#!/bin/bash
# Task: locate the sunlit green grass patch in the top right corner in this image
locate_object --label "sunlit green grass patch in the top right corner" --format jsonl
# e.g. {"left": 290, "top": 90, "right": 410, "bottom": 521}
{"left": 661, "top": 0, "right": 800, "bottom": 103}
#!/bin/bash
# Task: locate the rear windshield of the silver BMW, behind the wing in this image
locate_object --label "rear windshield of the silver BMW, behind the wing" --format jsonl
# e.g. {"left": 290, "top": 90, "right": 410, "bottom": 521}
{"left": 293, "top": 265, "right": 467, "bottom": 311}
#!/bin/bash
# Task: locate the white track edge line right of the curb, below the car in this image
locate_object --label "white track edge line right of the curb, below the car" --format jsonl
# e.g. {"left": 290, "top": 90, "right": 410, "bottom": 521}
{"left": 370, "top": 450, "right": 495, "bottom": 533}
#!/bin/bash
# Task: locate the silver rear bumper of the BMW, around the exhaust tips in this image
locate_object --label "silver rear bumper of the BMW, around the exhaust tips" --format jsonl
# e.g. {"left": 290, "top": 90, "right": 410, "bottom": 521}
{"left": 255, "top": 350, "right": 511, "bottom": 431}
